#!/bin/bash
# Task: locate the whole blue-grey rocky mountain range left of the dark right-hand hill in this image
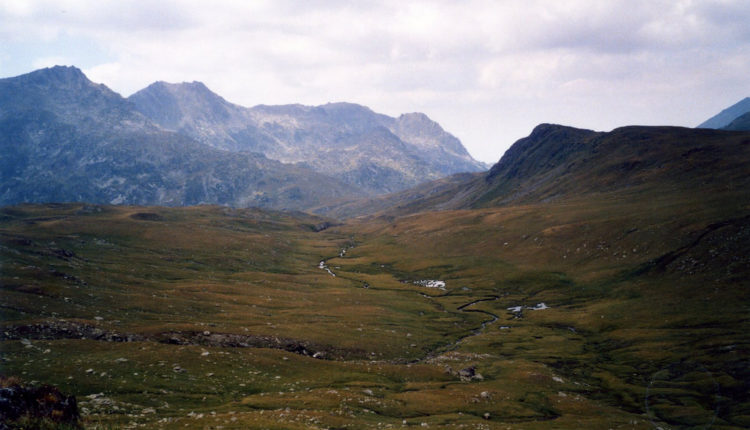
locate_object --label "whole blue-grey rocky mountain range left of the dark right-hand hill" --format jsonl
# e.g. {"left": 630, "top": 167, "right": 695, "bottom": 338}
{"left": 0, "top": 66, "right": 486, "bottom": 209}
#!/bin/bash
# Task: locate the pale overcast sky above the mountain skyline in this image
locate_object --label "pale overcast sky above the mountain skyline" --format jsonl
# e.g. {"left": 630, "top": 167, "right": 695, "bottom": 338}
{"left": 0, "top": 0, "right": 750, "bottom": 162}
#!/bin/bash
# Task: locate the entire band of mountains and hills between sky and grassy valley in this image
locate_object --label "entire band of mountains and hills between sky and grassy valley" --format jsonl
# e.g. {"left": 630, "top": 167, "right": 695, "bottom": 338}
{"left": 0, "top": 66, "right": 750, "bottom": 218}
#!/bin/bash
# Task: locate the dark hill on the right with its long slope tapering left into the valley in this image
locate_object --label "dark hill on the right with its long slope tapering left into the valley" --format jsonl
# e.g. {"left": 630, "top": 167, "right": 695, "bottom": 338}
{"left": 321, "top": 124, "right": 750, "bottom": 216}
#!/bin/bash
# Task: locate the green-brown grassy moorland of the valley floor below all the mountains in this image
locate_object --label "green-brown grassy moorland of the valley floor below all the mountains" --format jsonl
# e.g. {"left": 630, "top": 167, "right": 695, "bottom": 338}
{"left": 0, "top": 189, "right": 750, "bottom": 429}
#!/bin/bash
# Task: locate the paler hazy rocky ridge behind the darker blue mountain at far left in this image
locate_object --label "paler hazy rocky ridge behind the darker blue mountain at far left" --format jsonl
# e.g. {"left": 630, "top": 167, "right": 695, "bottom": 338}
{"left": 128, "top": 82, "right": 487, "bottom": 195}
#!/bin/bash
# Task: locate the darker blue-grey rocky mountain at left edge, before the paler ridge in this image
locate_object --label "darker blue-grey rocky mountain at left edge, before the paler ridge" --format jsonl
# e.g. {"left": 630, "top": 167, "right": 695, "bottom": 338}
{"left": 0, "top": 67, "right": 357, "bottom": 209}
